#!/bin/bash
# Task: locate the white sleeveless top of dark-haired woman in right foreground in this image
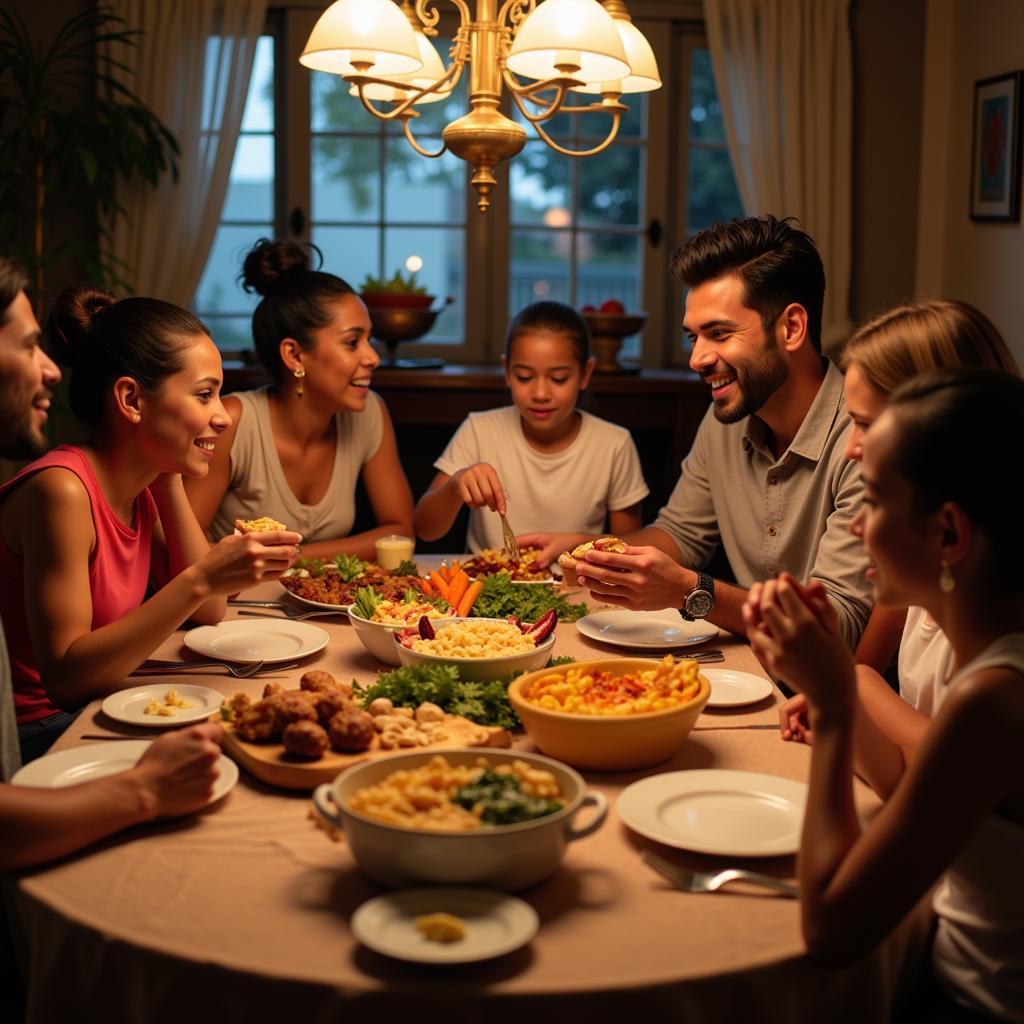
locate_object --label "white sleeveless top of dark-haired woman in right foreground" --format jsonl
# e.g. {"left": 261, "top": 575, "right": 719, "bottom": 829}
{"left": 933, "top": 633, "right": 1024, "bottom": 1022}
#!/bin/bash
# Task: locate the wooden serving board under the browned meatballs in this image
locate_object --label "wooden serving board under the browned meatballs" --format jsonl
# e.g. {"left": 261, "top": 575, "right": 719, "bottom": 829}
{"left": 221, "top": 715, "right": 512, "bottom": 791}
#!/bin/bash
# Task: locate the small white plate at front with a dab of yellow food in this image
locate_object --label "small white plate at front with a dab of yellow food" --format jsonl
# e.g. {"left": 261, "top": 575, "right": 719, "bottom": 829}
{"left": 350, "top": 888, "right": 540, "bottom": 964}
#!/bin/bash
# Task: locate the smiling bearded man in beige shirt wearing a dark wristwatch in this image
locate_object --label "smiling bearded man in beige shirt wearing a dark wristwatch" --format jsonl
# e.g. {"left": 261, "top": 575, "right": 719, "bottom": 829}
{"left": 519, "top": 215, "right": 871, "bottom": 647}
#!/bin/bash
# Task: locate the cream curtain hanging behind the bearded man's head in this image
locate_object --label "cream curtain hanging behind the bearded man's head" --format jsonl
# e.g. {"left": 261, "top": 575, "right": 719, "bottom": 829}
{"left": 703, "top": 0, "right": 853, "bottom": 348}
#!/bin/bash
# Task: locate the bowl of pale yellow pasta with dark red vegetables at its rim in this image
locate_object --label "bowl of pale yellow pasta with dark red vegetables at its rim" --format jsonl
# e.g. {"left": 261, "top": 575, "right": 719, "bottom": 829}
{"left": 393, "top": 618, "right": 555, "bottom": 682}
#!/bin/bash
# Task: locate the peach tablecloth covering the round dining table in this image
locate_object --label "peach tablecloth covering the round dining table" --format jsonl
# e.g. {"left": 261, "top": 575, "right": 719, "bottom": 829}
{"left": 12, "top": 565, "right": 932, "bottom": 1024}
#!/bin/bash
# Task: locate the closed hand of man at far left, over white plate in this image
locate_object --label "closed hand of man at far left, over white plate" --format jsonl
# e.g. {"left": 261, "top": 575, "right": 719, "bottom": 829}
{"left": 131, "top": 723, "right": 223, "bottom": 817}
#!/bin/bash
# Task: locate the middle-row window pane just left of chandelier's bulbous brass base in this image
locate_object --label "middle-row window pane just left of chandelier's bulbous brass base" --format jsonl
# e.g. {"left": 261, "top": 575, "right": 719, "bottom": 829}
{"left": 384, "top": 138, "right": 466, "bottom": 224}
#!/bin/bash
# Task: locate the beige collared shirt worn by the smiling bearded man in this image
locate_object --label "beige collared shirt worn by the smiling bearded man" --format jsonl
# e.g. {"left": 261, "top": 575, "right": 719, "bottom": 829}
{"left": 654, "top": 362, "right": 873, "bottom": 647}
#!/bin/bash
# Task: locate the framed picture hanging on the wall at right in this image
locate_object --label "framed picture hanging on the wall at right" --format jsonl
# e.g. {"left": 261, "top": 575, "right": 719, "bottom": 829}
{"left": 971, "top": 71, "right": 1024, "bottom": 221}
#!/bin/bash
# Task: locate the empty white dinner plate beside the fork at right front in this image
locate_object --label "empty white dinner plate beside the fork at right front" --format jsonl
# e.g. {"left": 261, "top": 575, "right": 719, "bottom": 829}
{"left": 615, "top": 768, "right": 807, "bottom": 857}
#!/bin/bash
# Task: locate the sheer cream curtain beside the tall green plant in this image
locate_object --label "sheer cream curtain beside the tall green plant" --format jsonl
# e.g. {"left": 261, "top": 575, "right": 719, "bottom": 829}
{"left": 99, "top": 0, "right": 267, "bottom": 306}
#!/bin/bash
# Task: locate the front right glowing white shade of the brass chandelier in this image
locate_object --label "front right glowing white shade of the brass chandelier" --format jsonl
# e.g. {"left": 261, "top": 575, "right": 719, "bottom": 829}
{"left": 508, "top": 0, "right": 631, "bottom": 83}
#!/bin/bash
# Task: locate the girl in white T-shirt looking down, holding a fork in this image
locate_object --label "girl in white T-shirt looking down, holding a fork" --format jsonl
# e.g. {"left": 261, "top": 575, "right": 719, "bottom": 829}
{"left": 415, "top": 302, "right": 648, "bottom": 552}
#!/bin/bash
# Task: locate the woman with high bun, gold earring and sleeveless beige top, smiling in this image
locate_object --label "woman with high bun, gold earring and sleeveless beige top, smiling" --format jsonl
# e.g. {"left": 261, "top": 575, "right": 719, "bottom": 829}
{"left": 188, "top": 239, "right": 413, "bottom": 558}
